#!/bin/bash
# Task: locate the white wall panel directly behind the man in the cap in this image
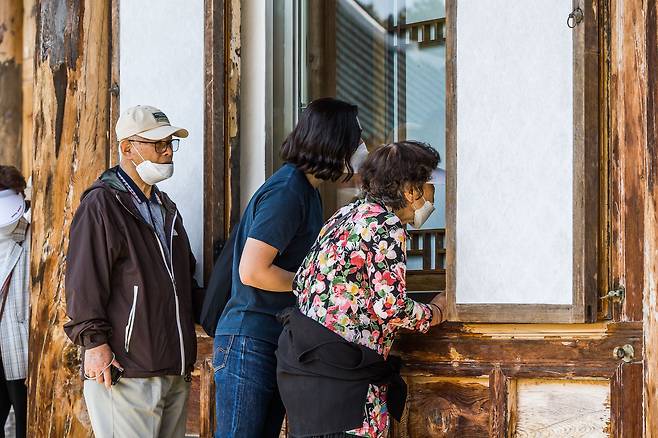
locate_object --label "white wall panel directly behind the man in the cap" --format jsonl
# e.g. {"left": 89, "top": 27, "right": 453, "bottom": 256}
{"left": 119, "top": 0, "right": 204, "bottom": 279}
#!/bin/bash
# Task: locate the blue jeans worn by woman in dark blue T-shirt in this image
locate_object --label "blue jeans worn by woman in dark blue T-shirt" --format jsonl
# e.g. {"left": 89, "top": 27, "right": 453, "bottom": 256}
{"left": 213, "top": 335, "right": 285, "bottom": 438}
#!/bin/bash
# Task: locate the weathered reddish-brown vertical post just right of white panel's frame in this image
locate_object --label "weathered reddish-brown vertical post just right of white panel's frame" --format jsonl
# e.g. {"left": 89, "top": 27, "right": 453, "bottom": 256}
{"left": 607, "top": 0, "right": 644, "bottom": 321}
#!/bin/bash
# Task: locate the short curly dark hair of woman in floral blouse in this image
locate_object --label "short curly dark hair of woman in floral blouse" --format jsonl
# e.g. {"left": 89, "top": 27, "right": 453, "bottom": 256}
{"left": 359, "top": 140, "right": 441, "bottom": 210}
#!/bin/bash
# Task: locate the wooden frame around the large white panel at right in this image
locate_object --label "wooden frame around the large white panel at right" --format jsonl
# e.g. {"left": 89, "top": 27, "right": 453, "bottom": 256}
{"left": 446, "top": 0, "right": 599, "bottom": 323}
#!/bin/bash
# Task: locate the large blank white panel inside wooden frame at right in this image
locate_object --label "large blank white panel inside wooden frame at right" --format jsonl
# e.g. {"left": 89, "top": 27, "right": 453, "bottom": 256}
{"left": 456, "top": 0, "right": 573, "bottom": 304}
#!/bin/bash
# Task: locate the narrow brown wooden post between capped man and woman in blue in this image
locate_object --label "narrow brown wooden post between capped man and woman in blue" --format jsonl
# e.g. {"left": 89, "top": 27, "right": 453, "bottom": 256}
{"left": 203, "top": 0, "right": 241, "bottom": 281}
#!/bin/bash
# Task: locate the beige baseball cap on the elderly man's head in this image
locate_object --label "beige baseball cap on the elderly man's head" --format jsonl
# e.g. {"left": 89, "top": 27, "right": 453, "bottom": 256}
{"left": 115, "top": 105, "right": 189, "bottom": 141}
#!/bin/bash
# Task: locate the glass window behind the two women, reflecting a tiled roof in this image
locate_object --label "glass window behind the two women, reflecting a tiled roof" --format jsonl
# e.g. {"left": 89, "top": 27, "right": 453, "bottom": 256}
{"left": 273, "top": 0, "right": 446, "bottom": 290}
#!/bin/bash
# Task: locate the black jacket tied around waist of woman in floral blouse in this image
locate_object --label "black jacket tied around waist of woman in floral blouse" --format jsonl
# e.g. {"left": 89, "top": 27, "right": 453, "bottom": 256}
{"left": 276, "top": 308, "right": 407, "bottom": 436}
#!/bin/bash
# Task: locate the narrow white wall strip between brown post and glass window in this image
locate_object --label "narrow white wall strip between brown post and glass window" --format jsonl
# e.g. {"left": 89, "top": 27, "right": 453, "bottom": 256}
{"left": 240, "top": 0, "right": 266, "bottom": 212}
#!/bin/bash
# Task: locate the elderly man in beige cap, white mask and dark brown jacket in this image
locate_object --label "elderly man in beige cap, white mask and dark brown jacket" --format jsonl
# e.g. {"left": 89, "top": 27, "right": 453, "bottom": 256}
{"left": 64, "top": 106, "right": 203, "bottom": 438}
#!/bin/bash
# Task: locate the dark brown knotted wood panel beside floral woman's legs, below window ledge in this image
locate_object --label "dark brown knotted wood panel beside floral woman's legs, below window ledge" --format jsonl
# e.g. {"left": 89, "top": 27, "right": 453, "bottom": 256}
{"left": 393, "top": 378, "right": 491, "bottom": 438}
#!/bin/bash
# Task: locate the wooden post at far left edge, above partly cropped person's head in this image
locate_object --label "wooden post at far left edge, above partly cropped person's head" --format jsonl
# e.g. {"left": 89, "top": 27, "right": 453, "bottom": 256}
{"left": 0, "top": 0, "right": 23, "bottom": 169}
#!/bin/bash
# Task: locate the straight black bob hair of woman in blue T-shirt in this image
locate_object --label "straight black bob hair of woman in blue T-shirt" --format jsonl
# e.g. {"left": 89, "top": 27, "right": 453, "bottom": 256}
{"left": 281, "top": 97, "right": 361, "bottom": 181}
